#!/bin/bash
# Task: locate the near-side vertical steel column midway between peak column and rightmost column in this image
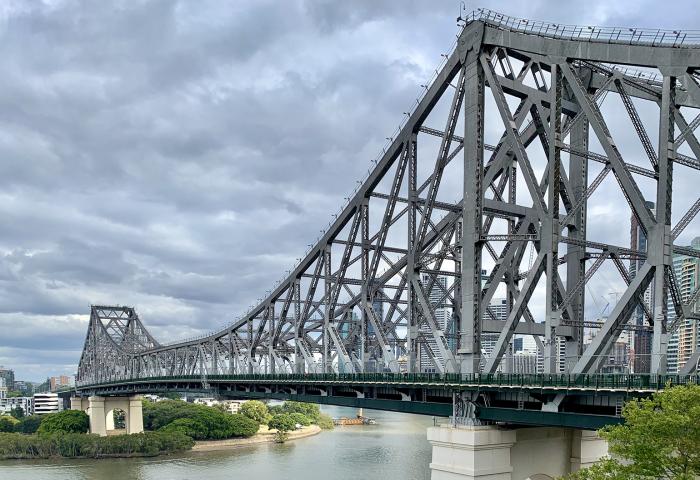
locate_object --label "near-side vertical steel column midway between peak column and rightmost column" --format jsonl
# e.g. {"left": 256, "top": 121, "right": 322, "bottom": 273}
{"left": 541, "top": 64, "right": 562, "bottom": 373}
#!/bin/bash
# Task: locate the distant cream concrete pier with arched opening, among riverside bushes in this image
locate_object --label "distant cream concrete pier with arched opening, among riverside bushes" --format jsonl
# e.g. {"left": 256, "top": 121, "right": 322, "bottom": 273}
{"left": 70, "top": 395, "right": 143, "bottom": 436}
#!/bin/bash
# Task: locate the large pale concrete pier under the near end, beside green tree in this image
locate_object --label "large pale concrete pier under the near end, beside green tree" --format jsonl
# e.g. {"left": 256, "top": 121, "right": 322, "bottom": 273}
{"left": 428, "top": 425, "right": 608, "bottom": 480}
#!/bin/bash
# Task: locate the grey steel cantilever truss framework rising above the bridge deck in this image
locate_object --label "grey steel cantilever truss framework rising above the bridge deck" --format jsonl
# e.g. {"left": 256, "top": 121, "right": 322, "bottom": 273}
{"left": 77, "top": 10, "right": 700, "bottom": 426}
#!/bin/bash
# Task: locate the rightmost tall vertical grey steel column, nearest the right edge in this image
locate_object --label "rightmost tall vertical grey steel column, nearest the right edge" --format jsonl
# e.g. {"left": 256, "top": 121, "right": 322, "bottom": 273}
{"left": 647, "top": 75, "right": 676, "bottom": 374}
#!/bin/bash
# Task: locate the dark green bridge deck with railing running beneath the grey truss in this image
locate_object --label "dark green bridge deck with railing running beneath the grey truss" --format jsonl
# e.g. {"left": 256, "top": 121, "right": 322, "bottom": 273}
{"left": 76, "top": 373, "right": 698, "bottom": 429}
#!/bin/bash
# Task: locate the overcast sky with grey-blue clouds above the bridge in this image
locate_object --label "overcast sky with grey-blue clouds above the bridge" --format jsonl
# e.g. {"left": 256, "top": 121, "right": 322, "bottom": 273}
{"left": 0, "top": 0, "right": 700, "bottom": 380}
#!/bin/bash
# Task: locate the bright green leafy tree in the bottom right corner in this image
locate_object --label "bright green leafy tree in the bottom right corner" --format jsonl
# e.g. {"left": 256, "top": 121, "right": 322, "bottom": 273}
{"left": 569, "top": 385, "right": 700, "bottom": 480}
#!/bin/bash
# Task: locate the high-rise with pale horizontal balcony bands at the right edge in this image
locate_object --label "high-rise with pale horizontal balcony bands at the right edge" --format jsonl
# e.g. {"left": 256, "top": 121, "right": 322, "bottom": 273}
{"left": 668, "top": 237, "right": 700, "bottom": 373}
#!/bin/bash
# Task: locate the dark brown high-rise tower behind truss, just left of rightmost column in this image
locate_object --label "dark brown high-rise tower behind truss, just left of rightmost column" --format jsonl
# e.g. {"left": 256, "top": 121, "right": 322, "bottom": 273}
{"left": 630, "top": 202, "right": 654, "bottom": 373}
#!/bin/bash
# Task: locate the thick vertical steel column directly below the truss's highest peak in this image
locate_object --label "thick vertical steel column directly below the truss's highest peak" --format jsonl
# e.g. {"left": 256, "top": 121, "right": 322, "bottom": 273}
{"left": 457, "top": 58, "right": 484, "bottom": 373}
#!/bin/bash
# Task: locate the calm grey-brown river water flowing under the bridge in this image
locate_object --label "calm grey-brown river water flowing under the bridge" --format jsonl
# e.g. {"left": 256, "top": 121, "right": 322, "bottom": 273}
{"left": 0, "top": 407, "right": 433, "bottom": 480}
